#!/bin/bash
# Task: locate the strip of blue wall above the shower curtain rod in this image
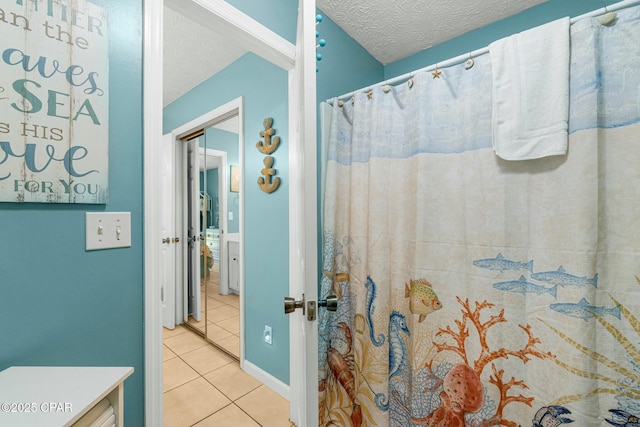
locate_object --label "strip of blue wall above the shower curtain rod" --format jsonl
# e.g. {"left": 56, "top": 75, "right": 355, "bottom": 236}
{"left": 384, "top": 0, "right": 618, "bottom": 78}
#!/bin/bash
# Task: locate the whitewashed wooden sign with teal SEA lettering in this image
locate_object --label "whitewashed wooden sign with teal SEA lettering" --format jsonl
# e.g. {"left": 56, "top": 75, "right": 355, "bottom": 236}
{"left": 0, "top": 0, "right": 109, "bottom": 203}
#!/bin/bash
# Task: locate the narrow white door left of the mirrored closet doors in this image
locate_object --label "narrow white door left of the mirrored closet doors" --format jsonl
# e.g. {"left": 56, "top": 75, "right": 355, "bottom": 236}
{"left": 160, "top": 134, "right": 179, "bottom": 329}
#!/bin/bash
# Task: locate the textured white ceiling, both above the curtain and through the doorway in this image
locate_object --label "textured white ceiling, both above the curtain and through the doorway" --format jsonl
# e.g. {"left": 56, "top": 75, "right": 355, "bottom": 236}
{"left": 164, "top": 0, "right": 546, "bottom": 106}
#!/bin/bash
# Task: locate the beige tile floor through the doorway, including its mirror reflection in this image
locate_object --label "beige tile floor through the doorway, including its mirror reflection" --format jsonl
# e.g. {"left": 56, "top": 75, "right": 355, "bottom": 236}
{"left": 162, "top": 266, "right": 291, "bottom": 427}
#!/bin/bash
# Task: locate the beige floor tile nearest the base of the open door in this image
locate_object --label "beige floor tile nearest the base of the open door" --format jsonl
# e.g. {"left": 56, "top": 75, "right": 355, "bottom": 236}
{"left": 235, "top": 385, "right": 291, "bottom": 427}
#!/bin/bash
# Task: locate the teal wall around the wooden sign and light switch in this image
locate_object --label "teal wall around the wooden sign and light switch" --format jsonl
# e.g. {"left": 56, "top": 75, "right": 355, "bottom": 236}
{"left": 0, "top": 0, "right": 144, "bottom": 426}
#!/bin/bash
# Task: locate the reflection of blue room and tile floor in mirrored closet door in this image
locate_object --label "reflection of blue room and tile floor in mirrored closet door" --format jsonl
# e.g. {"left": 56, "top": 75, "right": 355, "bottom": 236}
{"left": 188, "top": 110, "right": 241, "bottom": 359}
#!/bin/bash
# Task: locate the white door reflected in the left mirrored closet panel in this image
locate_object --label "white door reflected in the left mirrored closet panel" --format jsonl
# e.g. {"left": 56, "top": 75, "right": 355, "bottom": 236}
{"left": 183, "top": 138, "right": 200, "bottom": 322}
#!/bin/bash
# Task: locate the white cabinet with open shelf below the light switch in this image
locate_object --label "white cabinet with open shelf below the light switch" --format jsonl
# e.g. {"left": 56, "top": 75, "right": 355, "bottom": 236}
{"left": 0, "top": 366, "right": 133, "bottom": 427}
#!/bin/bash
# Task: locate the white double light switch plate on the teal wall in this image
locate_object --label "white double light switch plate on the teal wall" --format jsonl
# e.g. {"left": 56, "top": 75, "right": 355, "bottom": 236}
{"left": 85, "top": 212, "right": 131, "bottom": 251}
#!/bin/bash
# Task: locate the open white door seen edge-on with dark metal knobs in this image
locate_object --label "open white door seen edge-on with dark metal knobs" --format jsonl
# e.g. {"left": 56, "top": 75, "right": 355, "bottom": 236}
{"left": 289, "top": 0, "right": 318, "bottom": 427}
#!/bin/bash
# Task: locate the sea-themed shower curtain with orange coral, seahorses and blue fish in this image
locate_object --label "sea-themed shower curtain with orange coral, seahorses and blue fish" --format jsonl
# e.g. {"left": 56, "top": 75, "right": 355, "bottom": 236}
{"left": 319, "top": 7, "right": 640, "bottom": 427}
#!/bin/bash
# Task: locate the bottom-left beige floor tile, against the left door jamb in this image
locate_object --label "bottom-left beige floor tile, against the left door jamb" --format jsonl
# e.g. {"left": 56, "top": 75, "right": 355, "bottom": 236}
{"left": 163, "top": 377, "right": 231, "bottom": 427}
